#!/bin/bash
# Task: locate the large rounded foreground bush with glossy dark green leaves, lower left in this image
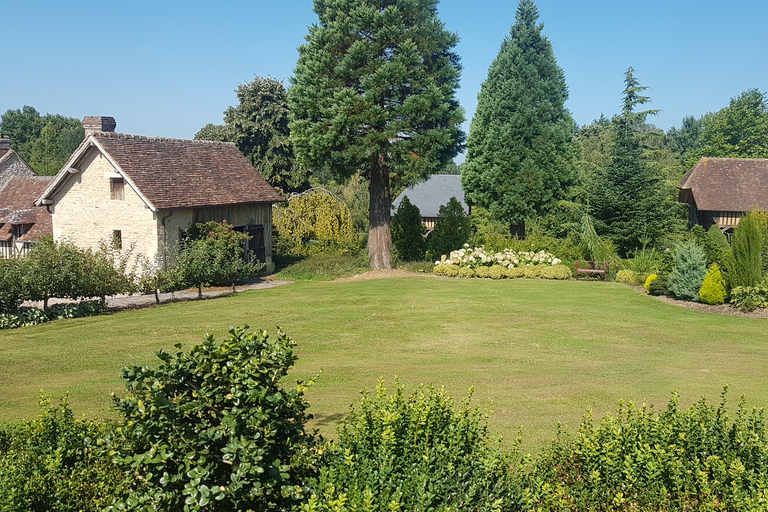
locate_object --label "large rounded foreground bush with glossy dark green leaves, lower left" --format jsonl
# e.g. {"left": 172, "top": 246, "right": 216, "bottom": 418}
{"left": 115, "top": 327, "right": 316, "bottom": 511}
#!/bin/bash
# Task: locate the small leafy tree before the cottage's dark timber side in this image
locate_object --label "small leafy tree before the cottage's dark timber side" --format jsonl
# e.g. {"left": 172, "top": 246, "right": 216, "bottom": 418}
{"left": 176, "top": 221, "right": 264, "bottom": 298}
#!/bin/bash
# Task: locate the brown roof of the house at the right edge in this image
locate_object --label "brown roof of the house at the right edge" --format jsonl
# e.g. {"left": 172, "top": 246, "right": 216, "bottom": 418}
{"left": 680, "top": 158, "right": 768, "bottom": 212}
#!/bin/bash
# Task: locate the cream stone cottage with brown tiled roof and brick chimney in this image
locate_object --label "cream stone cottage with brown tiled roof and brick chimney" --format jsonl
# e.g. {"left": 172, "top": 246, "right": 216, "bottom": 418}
{"left": 37, "top": 116, "right": 283, "bottom": 268}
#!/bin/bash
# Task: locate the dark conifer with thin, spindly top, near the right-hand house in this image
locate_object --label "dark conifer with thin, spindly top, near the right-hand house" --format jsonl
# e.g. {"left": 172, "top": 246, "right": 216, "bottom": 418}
{"left": 589, "top": 67, "right": 681, "bottom": 255}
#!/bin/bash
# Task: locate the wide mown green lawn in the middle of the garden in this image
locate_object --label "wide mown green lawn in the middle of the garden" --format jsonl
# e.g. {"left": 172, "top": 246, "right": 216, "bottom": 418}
{"left": 0, "top": 276, "right": 768, "bottom": 446}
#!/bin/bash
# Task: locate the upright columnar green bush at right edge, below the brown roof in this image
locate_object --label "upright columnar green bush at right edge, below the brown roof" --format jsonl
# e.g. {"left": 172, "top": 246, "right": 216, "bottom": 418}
{"left": 728, "top": 212, "right": 763, "bottom": 288}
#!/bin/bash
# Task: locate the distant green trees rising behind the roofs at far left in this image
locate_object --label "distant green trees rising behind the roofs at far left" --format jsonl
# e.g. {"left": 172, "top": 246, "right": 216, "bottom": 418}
{"left": 0, "top": 105, "right": 85, "bottom": 176}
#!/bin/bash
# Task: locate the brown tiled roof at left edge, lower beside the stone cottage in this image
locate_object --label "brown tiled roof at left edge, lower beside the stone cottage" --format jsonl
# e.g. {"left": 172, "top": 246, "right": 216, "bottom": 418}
{"left": 0, "top": 176, "right": 54, "bottom": 240}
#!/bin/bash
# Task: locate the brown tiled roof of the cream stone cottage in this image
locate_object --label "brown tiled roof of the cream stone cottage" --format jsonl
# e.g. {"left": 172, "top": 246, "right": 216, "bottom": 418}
{"left": 92, "top": 132, "right": 284, "bottom": 209}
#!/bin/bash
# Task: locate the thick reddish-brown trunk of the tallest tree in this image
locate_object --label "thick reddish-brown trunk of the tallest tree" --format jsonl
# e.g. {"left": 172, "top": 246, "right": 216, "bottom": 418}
{"left": 368, "top": 155, "right": 392, "bottom": 270}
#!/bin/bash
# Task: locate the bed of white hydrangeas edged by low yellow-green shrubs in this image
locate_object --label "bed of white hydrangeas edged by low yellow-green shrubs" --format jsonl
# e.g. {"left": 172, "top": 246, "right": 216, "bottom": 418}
{"left": 435, "top": 244, "right": 572, "bottom": 279}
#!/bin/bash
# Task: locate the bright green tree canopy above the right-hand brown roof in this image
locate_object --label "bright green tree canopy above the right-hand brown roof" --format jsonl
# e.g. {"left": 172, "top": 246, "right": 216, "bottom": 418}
{"left": 696, "top": 89, "right": 768, "bottom": 160}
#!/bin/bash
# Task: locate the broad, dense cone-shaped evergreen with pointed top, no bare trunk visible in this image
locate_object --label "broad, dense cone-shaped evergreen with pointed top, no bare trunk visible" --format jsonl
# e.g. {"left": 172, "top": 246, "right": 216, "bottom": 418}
{"left": 461, "top": 0, "right": 575, "bottom": 236}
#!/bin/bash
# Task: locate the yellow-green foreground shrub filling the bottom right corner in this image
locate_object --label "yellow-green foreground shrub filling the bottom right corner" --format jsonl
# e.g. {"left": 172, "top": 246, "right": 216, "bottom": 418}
{"left": 530, "top": 393, "right": 768, "bottom": 511}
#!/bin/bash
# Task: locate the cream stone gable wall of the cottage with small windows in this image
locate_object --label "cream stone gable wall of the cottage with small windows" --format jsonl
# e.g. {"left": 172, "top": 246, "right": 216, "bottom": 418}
{"left": 51, "top": 148, "right": 158, "bottom": 258}
